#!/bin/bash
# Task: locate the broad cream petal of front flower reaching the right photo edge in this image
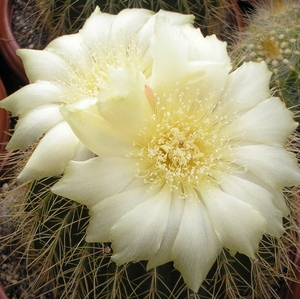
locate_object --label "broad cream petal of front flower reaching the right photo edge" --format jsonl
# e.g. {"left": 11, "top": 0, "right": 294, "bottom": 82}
{"left": 235, "top": 145, "right": 300, "bottom": 189}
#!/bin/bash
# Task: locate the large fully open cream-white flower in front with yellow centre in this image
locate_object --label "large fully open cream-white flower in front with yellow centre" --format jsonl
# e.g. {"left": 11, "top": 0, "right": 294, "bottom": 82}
{"left": 52, "top": 13, "right": 300, "bottom": 291}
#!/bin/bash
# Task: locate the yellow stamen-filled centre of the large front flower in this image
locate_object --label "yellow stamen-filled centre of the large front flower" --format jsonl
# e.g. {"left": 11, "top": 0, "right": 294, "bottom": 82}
{"left": 134, "top": 89, "right": 241, "bottom": 193}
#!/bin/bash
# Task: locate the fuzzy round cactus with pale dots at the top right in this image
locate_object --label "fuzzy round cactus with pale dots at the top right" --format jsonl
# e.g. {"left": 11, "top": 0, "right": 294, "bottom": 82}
{"left": 231, "top": 0, "right": 300, "bottom": 111}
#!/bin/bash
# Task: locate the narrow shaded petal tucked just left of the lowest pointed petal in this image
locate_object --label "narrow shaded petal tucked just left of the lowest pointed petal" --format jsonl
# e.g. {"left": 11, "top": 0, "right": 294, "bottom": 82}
{"left": 147, "top": 193, "right": 184, "bottom": 270}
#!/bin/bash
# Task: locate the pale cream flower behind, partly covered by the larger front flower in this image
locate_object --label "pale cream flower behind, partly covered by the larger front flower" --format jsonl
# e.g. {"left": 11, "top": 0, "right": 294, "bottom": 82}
{"left": 0, "top": 8, "right": 194, "bottom": 180}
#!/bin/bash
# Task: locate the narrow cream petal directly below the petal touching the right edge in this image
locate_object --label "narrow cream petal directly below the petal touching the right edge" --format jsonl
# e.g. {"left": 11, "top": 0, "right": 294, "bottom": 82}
{"left": 221, "top": 175, "right": 284, "bottom": 238}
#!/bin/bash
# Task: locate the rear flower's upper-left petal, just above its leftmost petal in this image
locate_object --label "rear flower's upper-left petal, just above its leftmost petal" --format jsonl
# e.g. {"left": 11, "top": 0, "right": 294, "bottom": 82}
{"left": 17, "top": 49, "right": 73, "bottom": 83}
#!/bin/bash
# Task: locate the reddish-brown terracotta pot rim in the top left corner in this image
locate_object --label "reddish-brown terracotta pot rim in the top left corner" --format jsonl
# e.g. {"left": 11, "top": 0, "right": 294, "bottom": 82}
{"left": 0, "top": 0, "right": 28, "bottom": 84}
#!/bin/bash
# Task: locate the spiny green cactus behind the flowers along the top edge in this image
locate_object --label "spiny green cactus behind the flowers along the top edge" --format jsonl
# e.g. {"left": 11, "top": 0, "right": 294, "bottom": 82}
{"left": 41, "top": 0, "right": 231, "bottom": 39}
